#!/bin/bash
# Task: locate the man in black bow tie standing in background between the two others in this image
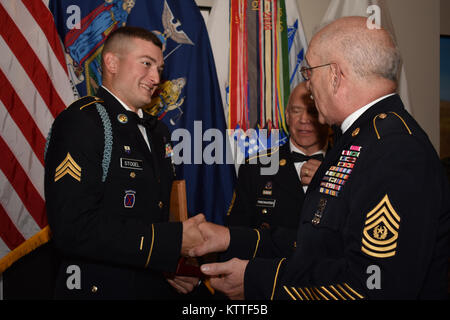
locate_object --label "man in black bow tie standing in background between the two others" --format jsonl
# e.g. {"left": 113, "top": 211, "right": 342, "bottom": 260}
{"left": 226, "top": 83, "right": 328, "bottom": 234}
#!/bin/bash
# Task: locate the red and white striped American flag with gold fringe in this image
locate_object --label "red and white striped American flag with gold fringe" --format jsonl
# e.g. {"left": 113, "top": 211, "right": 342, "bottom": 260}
{"left": 0, "top": 0, "right": 74, "bottom": 275}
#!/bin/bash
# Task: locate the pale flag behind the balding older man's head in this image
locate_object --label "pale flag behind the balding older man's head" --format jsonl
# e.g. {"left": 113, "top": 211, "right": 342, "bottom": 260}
{"left": 321, "top": 0, "right": 413, "bottom": 114}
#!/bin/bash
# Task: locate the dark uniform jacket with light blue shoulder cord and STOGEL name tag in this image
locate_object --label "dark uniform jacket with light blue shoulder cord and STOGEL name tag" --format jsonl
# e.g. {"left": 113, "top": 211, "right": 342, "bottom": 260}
{"left": 45, "top": 88, "right": 182, "bottom": 299}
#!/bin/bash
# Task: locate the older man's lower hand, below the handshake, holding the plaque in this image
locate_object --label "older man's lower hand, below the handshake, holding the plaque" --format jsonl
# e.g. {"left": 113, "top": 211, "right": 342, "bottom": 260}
{"left": 200, "top": 258, "right": 248, "bottom": 300}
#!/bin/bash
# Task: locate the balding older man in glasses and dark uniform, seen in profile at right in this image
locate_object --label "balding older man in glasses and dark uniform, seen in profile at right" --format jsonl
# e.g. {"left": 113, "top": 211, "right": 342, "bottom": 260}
{"left": 191, "top": 17, "right": 450, "bottom": 300}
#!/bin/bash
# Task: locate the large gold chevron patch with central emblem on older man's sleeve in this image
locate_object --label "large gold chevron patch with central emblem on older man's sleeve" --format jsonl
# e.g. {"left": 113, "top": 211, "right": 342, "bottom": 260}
{"left": 361, "top": 195, "right": 400, "bottom": 258}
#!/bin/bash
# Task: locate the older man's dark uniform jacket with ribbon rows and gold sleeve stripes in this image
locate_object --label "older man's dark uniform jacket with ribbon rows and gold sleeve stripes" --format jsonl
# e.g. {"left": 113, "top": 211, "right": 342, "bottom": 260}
{"left": 228, "top": 95, "right": 450, "bottom": 300}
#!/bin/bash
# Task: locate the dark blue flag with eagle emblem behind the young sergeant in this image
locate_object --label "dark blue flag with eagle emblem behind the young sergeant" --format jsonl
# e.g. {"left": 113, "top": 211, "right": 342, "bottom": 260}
{"left": 50, "top": 0, "right": 235, "bottom": 224}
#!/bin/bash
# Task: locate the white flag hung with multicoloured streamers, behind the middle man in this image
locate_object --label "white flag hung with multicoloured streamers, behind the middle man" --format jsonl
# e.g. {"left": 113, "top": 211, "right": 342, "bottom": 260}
{"left": 208, "top": 0, "right": 307, "bottom": 158}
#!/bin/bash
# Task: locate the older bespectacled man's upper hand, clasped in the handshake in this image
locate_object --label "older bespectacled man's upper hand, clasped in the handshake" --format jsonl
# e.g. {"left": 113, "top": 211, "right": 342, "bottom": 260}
{"left": 189, "top": 222, "right": 230, "bottom": 257}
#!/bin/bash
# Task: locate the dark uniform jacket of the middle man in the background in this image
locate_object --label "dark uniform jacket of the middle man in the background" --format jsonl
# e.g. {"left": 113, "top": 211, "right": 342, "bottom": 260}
{"left": 224, "top": 142, "right": 322, "bottom": 258}
